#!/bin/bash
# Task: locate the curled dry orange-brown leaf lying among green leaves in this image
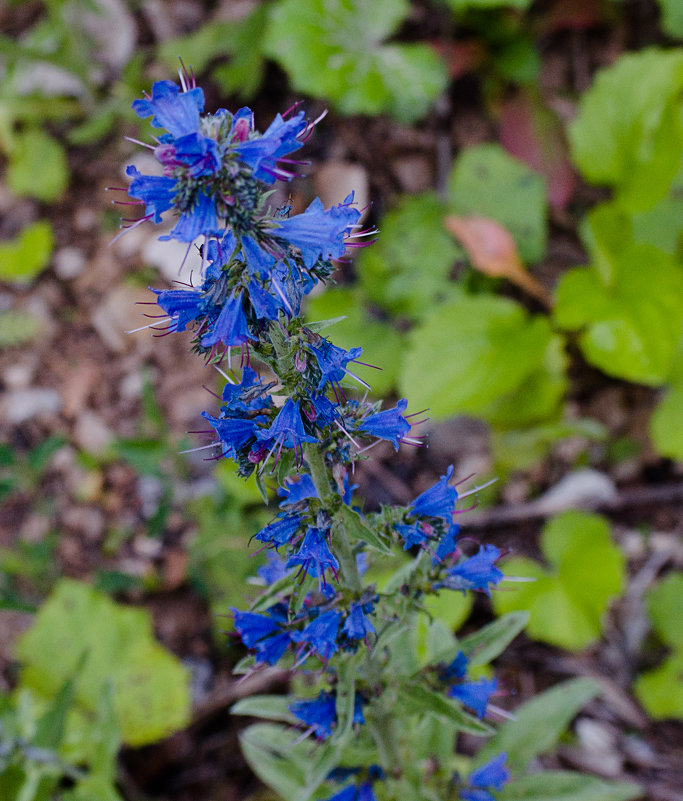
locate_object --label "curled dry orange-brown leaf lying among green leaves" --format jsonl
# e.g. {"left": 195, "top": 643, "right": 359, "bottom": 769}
{"left": 445, "top": 215, "right": 551, "bottom": 306}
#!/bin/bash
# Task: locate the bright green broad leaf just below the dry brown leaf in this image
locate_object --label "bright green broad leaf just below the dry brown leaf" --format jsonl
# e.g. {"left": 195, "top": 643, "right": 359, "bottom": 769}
{"left": 400, "top": 294, "right": 555, "bottom": 420}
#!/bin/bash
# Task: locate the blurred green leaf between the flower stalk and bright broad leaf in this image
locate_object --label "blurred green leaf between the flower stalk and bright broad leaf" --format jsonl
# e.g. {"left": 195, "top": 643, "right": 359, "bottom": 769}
{"left": 306, "top": 289, "right": 404, "bottom": 396}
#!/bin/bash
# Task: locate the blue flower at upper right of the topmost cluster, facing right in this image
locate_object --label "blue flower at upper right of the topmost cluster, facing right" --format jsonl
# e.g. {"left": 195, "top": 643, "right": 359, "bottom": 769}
{"left": 235, "top": 111, "right": 308, "bottom": 184}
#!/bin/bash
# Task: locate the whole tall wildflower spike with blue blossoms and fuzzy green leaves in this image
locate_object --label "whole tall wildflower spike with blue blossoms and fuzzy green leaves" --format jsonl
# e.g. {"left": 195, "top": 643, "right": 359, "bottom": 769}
{"left": 120, "top": 68, "right": 524, "bottom": 801}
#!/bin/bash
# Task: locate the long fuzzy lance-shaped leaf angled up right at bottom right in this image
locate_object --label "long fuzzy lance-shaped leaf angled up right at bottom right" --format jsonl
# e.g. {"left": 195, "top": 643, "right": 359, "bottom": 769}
{"left": 475, "top": 679, "right": 602, "bottom": 775}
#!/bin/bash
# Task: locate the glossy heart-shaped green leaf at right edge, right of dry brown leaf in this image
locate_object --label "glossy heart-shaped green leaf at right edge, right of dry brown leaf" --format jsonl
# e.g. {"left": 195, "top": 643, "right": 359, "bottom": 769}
{"left": 555, "top": 243, "right": 683, "bottom": 386}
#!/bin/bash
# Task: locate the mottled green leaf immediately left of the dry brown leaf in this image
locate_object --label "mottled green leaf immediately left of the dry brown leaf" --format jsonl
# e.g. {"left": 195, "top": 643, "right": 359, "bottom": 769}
{"left": 357, "top": 193, "right": 462, "bottom": 319}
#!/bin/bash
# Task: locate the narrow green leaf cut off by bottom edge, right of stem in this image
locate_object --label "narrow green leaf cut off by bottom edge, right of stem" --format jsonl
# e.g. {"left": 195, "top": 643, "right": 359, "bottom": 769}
{"left": 498, "top": 771, "right": 643, "bottom": 801}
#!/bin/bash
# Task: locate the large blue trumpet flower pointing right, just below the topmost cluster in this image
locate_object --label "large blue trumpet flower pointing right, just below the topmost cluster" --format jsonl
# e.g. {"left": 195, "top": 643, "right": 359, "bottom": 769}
{"left": 272, "top": 194, "right": 360, "bottom": 269}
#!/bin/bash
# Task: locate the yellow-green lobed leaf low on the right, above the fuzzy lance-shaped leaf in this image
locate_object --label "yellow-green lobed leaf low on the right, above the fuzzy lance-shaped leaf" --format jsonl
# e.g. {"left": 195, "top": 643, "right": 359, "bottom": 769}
{"left": 493, "top": 511, "right": 625, "bottom": 650}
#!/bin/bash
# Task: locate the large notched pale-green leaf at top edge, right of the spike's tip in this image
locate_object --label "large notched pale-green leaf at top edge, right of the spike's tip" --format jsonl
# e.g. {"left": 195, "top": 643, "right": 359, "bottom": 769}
{"left": 265, "top": 0, "right": 447, "bottom": 123}
